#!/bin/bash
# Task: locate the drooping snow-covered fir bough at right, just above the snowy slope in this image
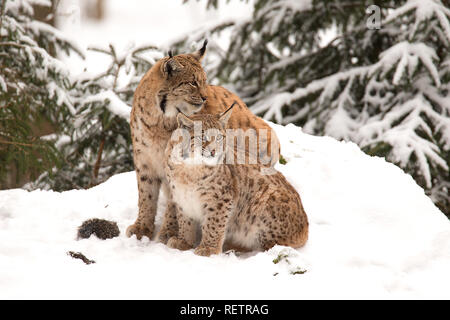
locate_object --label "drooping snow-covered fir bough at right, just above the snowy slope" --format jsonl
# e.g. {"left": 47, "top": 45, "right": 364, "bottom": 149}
{"left": 251, "top": 34, "right": 450, "bottom": 188}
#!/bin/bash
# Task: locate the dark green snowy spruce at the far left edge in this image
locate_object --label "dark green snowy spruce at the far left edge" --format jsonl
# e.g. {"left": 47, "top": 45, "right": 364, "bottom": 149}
{"left": 0, "top": 0, "right": 82, "bottom": 189}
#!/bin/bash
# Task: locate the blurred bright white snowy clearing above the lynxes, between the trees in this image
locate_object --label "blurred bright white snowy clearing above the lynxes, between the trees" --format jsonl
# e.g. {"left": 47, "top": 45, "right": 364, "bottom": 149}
{"left": 57, "top": 0, "right": 253, "bottom": 73}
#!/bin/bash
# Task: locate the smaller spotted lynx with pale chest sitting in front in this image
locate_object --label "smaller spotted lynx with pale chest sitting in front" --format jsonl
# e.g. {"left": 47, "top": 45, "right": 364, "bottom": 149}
{"left": 165, "top": 107, "right": 308, "bottom": 256}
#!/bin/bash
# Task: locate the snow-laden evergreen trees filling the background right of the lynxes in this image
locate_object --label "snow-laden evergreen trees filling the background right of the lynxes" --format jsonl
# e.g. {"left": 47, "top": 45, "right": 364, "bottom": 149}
{"left": 178, "top": 0, "right": 450, "bottom": 217}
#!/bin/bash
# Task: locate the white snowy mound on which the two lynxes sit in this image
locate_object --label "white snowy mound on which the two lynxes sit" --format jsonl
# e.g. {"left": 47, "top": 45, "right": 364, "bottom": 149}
{"left": 0, "top": 125, "right": 450, "bottom": 299}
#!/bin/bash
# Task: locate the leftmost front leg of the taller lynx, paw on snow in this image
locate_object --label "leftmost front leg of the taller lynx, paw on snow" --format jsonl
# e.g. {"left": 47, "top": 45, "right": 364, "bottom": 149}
{"left": 126, "top": 170, "right": 161, "bottom": 240}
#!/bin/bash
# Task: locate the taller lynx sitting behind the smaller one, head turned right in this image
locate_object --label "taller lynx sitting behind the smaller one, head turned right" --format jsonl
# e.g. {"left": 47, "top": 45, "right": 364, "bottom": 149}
{"left": 126, "top": 41, "right": 279, "bottom": 243}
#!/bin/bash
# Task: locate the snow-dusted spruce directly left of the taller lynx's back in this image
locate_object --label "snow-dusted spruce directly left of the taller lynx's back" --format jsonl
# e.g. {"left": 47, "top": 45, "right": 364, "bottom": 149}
{"left": 33, "top": 45, "right": 162, "bottom": 191}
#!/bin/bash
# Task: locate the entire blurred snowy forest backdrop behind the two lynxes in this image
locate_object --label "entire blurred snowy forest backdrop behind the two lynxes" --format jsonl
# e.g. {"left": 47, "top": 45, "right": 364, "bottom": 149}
{"left": 0, "top": 0, "right": 450, "bottom": 217}
